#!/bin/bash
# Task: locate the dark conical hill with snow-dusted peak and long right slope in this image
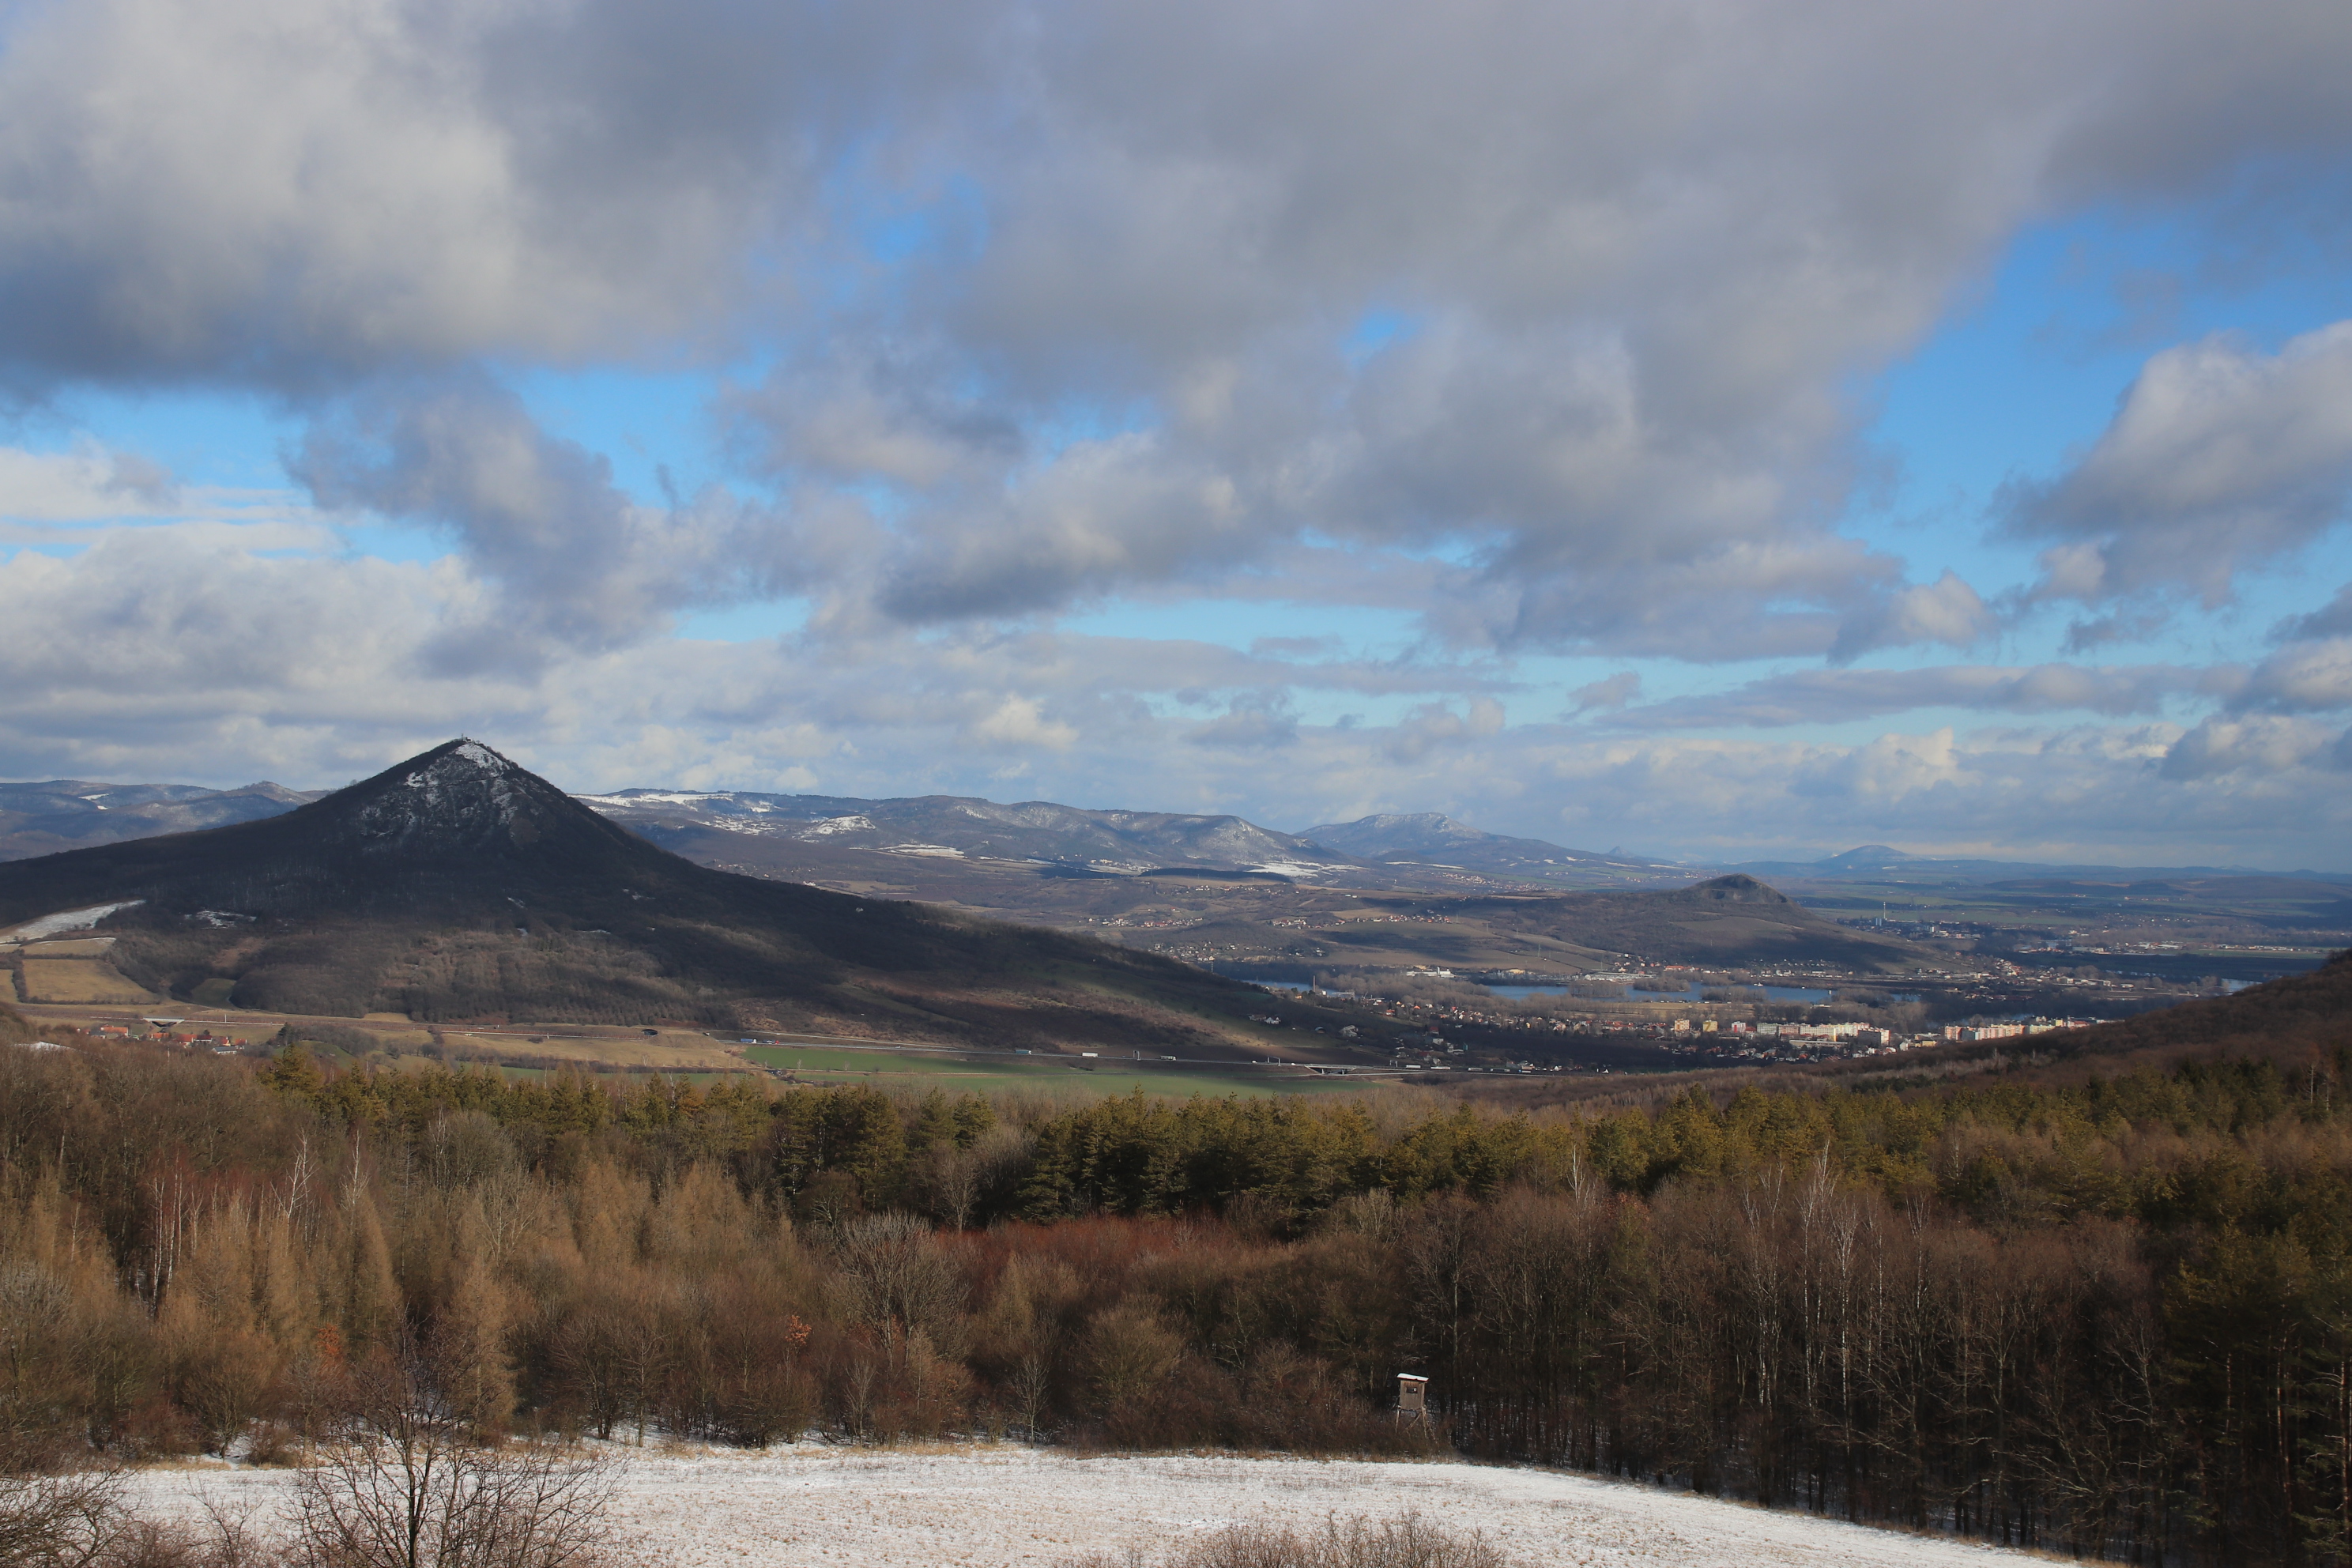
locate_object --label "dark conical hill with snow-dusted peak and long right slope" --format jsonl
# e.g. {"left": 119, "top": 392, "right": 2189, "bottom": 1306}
{"left": 0, "top": 741, "right": 1345, "bottom": 1051}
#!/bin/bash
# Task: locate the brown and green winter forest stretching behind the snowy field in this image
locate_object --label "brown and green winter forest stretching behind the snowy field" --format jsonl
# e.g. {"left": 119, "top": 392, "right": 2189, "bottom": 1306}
{"left": 0, "top": 982, "right": 2352, "bottom": 1563}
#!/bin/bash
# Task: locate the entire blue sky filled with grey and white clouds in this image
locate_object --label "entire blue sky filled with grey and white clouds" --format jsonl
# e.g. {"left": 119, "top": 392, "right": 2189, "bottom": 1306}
{"left": 0, "top": 0, "right": 2352, "bottom": 873}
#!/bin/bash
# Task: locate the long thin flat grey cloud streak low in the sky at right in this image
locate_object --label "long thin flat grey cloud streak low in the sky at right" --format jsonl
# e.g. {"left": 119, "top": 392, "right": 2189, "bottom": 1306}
{"left": 1611, "top": 665, "right": 2234, "bottom": 731}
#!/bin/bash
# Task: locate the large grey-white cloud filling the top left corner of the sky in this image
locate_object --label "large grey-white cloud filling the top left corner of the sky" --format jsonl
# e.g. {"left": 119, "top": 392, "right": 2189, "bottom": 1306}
{"left": 0, "top": 0, "right": 971, "bottom": 388}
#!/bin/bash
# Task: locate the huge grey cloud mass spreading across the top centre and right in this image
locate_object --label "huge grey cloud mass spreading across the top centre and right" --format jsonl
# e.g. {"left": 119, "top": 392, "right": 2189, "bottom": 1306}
{"left": 832, "top": 7, "right": 2345, "bottom": 656}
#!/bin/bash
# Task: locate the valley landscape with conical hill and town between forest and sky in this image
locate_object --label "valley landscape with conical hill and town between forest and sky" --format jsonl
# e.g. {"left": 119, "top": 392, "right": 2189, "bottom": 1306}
{"left": 0, "top": 743, "right": 2352, "bottom": 1093}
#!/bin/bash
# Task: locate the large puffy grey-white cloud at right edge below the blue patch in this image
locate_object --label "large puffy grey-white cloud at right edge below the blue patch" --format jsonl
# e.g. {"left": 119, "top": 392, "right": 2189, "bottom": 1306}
{"left": 2007, "top": 322, "right": 2352, "bottom": 606}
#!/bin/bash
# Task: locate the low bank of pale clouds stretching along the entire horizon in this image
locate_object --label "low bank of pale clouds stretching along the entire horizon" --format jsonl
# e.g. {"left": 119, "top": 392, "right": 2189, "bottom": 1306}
{"left": 0, "top": 529, "right": 2352, "bottom": 868}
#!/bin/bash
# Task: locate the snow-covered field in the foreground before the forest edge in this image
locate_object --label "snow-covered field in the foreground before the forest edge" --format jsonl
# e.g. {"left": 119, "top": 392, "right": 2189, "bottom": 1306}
{"left": 134, "top": 1443, "right": 2027, "bottom": 1568}
